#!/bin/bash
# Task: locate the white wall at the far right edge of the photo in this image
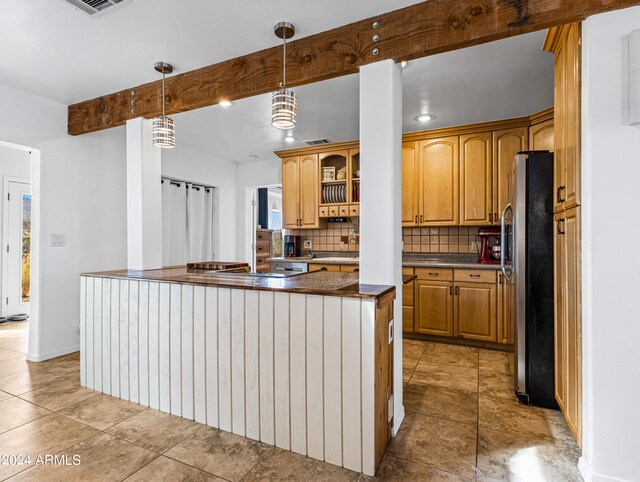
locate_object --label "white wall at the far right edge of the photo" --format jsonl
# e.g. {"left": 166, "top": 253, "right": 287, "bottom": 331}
{"left": 580, "top": 7, "right": 640, "bottom": 481}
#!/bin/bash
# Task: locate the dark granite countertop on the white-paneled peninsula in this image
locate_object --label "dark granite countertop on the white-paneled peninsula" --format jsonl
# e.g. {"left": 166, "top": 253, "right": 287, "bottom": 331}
{"left": 82, "top": 266, "right": 395, "bottom": 300}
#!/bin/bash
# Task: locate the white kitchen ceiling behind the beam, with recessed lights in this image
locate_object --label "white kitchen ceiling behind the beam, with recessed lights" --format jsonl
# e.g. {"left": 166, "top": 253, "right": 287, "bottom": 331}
{"left": 173, "top": 32, "right": 553, "bottom": 162}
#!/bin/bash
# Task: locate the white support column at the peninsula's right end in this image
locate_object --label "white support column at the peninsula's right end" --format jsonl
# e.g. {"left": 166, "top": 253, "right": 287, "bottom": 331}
{"left": 360, "top": 60, "right": 404, "bottom": 435}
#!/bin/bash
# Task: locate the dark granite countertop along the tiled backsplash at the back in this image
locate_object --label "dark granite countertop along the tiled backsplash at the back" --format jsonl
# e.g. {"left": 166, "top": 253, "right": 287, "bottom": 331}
{"left": 267, "top": 253, "right": 500, "bottom": 270}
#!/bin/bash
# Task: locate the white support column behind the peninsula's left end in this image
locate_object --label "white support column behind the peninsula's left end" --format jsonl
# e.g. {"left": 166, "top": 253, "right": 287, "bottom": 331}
{"left": 127, "top": 118, "right": 162, "bottom": 269}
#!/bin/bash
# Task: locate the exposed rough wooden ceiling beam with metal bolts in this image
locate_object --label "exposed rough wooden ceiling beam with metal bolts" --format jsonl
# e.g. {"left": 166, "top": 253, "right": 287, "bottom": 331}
{"left": 68, "top": 0, "right": 640, "bottom": 135}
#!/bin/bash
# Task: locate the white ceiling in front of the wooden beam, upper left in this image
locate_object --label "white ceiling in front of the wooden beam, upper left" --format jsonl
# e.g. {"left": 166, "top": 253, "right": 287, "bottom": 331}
{"left": 0, "top": 0, "right": 420, "bottom": 104}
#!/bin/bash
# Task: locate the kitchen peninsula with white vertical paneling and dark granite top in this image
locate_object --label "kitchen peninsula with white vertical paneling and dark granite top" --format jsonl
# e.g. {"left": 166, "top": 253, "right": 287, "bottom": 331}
{"left": 80, "top": 267, "right": 395, "bottom": 475}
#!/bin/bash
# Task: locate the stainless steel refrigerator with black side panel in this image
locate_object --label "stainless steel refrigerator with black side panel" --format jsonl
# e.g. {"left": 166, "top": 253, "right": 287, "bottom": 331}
{"left": 500, "top": 151, "right": 558, "bottom": 408}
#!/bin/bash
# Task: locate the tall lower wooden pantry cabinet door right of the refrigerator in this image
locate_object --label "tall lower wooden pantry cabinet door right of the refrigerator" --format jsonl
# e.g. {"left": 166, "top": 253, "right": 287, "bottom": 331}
{"left": 554, "top": 207, "right": 582, "bottom": 444}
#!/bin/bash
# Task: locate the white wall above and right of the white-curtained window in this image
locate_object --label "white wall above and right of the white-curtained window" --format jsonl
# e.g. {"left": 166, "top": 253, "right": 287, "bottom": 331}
{"left": 162, "top": 144, "right": 241, "bottom": 261}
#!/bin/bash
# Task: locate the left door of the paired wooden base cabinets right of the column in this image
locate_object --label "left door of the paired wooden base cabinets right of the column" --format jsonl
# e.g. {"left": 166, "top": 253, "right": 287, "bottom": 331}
{"left": 414, "top": 279, "right": 453, "bottom": 336}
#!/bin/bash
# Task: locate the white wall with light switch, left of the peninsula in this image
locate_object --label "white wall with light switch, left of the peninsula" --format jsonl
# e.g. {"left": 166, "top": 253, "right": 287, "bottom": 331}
{"left": 33, "top": 127, "right": 127, "bottom": 357}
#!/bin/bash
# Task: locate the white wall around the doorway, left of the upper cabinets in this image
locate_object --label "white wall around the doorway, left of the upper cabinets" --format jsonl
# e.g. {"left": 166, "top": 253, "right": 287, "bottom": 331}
{"left": 232, "top": 159, "right": 282, "bottom": 262}
